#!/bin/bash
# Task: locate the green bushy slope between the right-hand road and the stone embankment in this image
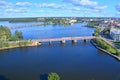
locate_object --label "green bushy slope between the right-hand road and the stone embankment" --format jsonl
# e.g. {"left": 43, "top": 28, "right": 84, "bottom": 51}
{"left": 93, "top": 38, "right": 120, "bottom": 56}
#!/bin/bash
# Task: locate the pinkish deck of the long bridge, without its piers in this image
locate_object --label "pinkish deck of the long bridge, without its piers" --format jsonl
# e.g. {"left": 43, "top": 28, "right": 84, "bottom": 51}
{"left": 35, "top": 36, "right": 95, "bottom": 42}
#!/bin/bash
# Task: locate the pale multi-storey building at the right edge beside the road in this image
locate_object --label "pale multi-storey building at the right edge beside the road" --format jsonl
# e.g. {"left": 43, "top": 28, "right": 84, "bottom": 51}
{"left": 110, "top": 28, "right": 120, "bottom": 42}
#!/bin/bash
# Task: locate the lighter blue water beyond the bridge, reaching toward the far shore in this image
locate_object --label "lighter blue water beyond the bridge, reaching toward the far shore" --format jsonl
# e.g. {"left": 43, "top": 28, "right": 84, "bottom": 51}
{"left": 0, "top": 22, "right": 94, "bottom": 39}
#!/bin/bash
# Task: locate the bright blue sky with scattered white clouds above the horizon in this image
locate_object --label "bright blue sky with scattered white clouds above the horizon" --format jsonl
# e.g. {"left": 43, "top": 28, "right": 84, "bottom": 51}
{"left": 0, "top": 0, "right": 120, "bottom": 18}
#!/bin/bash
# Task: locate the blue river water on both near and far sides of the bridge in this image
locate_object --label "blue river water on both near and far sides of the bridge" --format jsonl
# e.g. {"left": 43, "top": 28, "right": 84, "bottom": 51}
{"left": 0, "top": 21, "right": 120, "bottom": 80}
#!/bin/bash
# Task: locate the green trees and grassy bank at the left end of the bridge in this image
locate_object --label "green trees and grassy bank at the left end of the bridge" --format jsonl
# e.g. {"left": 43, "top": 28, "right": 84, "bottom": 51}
{"left": 0, "top": 26, "right": 32, "bottom": 49}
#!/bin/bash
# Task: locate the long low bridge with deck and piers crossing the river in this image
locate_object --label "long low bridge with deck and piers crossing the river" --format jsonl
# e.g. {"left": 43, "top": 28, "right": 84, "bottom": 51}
{"left": 33, "top": 36, "right": 95, "bottom": 44}
